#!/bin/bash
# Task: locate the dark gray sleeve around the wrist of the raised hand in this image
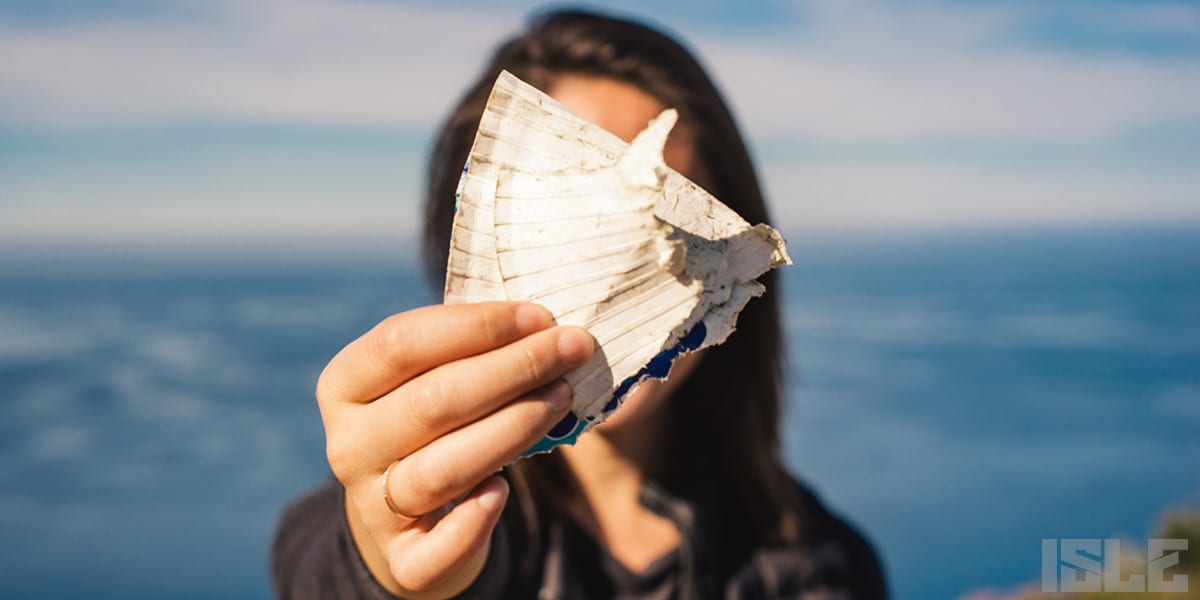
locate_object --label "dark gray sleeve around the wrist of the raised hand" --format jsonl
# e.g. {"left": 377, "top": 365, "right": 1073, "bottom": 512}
{"left": 271, "top": 480, "right": 512, "bottom": 600}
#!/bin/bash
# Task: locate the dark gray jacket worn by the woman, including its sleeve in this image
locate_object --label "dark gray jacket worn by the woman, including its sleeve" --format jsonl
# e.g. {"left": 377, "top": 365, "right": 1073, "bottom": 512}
{"left": 271, "top": 480, "right": 887, "bottom": 600}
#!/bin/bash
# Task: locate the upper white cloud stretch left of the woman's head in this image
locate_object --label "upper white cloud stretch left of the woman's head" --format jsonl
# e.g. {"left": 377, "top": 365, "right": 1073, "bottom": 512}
{"left": 0, "top": 0, "right": 520, "bottom": 130}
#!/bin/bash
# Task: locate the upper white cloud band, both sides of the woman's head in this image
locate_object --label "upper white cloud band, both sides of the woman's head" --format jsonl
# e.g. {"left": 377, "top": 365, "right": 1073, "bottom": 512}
{"left": 0, "top": 0, "right": 1200, "bottom": 139}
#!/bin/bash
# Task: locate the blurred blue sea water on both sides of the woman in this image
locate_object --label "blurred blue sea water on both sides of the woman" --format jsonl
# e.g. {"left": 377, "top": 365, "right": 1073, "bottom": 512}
{"left": 0, "top": 227, "right": 1200, "bottom": 599}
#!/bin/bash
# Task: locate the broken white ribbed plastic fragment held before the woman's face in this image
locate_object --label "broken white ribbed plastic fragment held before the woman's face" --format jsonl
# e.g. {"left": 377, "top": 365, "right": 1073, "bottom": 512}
{"left": 445, "top": 71, "right": 792, "bottom": 454}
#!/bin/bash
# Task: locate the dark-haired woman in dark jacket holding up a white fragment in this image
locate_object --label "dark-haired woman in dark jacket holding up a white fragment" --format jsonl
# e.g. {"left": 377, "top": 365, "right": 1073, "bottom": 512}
{"left": 272, "top": 12, "right": 886, "bottom": 598}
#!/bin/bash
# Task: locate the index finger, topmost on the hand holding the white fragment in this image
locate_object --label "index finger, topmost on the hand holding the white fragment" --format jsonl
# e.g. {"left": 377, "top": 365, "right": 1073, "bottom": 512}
{"left": 317, "top": 302, "right": 554, "bottom": 403}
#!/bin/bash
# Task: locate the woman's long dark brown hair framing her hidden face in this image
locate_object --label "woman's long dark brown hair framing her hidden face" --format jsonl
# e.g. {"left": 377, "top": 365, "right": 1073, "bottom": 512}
{"left": 425, "top": 11, "right": 803, "bottom": 571}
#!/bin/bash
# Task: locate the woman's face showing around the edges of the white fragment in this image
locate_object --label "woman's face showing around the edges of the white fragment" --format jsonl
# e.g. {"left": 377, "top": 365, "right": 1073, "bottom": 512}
{"left": 547, "top": 74, "right": 703, "bottom": 432}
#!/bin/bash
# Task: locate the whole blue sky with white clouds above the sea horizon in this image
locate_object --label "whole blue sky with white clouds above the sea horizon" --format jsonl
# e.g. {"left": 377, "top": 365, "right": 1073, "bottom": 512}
{"left": 0, "top": 0, "right": 1200, "bottom": 244}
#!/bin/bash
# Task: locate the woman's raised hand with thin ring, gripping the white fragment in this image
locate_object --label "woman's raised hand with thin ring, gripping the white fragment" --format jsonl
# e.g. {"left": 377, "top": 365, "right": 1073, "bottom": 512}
{"left": 317, "top": 302, "right": 594, "bottom": 598}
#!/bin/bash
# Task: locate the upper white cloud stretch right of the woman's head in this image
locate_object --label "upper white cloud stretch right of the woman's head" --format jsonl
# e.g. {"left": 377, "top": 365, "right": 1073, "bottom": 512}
{"left": 706, "top": 2, "right": 1200, "bottom": 140}
